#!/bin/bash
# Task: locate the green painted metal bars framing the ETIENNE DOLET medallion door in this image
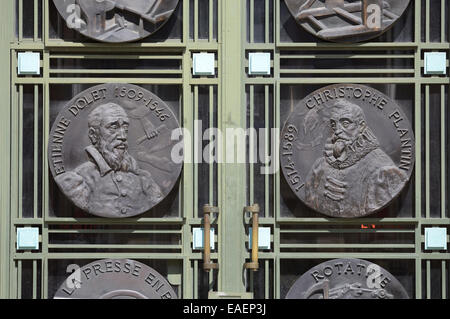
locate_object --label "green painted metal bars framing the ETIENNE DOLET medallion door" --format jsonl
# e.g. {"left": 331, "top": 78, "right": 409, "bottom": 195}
{"left": 0, "top": 0, "right": 224, "bottom": 298}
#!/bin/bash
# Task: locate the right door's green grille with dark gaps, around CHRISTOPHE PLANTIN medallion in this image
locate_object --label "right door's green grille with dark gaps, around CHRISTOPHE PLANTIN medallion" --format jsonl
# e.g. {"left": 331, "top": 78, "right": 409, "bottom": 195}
{"left": 244, "top": 0, "right": 450, "bottom": 299}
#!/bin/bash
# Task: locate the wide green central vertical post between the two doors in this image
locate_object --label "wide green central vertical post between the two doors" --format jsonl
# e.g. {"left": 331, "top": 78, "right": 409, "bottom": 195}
{"left": 219, "top": 1, "right": 248, "bottom": 293}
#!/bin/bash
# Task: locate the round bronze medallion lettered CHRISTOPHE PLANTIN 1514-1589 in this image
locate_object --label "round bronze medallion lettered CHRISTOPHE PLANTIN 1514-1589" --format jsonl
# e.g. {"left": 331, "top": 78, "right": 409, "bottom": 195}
{"left": 280, "top": 84, "right": 415, "bottom": 218}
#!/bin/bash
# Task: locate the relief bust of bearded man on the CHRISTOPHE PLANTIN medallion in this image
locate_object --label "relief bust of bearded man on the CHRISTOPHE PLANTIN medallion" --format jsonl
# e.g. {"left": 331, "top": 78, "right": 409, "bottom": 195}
{"left": 305, "top": 99, "right": 407, "bottom": 217}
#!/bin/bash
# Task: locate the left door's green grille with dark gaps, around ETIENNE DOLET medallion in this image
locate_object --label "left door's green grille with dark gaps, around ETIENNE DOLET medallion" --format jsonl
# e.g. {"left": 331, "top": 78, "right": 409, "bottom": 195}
{"left": 2, "top": 0, "right": 220, "bottom": 298}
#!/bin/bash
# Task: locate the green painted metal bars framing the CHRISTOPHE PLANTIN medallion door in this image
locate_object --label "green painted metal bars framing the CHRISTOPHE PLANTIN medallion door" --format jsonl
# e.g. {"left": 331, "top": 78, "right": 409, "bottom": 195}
{"left": 243, "top": 0, "right": 450, "bottom": 299}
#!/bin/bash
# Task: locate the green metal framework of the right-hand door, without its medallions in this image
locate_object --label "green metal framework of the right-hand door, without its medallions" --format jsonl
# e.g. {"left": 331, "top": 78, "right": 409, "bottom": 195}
{"left": 244, "top": 0, "right": 450, "bottom": 298}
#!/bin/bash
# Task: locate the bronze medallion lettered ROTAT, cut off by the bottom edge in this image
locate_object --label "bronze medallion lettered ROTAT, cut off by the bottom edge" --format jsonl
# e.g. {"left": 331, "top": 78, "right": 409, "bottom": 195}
{"left": 286, "top": 259, "right": 409, "bottom": 299}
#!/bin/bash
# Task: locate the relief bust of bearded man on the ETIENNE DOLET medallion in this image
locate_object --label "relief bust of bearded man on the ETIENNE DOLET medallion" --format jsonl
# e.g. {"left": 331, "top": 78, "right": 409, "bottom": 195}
{"left": 56, "top": 103, "right": 163, "bottom": 217}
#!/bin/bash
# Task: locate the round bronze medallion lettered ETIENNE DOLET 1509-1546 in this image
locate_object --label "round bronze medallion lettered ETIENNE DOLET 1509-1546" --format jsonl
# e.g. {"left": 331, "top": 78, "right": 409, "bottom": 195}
{"left": 48, "top": 84, "right": 182, "bottom": 218}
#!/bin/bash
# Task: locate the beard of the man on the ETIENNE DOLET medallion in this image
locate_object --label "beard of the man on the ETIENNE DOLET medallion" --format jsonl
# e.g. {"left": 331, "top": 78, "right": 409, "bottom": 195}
{"left": 97, "top": 140, "right": 131, "bottom": 172}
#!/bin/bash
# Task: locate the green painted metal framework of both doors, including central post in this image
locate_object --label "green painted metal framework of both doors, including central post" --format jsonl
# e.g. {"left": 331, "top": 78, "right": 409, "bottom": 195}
{"left": 0, "top": 0, "right": 450, "bottom": 298}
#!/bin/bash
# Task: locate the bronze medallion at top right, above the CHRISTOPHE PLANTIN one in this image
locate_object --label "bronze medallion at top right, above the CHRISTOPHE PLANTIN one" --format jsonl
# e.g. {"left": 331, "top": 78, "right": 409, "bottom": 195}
{"left": 285, "top": 0, "right": 409, "bottom": 43}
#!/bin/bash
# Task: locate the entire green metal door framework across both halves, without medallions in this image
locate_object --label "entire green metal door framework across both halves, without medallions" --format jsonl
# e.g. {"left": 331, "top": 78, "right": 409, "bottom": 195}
{"left": 0, "top": 0, "right": 450, "bottom": 298}
